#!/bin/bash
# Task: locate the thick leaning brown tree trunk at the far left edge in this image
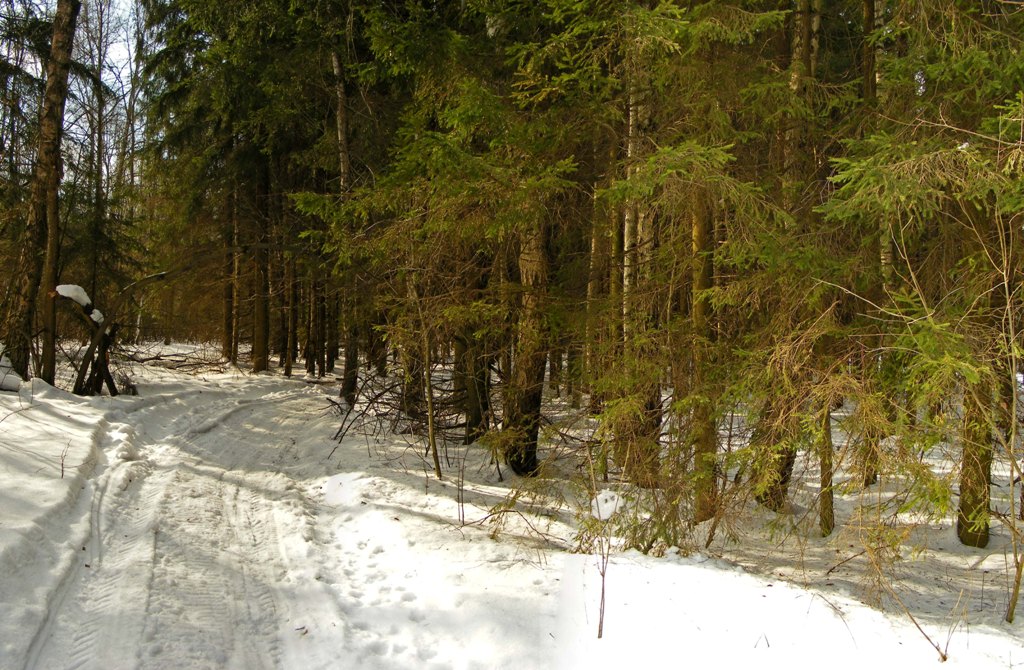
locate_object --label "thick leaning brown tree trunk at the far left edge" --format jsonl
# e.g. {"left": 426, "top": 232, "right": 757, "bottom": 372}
{"left": 2, "top": 0, "right": 82, "bottom": 379}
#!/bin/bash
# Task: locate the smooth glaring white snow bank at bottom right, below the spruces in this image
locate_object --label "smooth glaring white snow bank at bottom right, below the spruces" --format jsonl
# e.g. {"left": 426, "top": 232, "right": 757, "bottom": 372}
{"left": 550, "top": 552, "right": 1024, "bottom": 670}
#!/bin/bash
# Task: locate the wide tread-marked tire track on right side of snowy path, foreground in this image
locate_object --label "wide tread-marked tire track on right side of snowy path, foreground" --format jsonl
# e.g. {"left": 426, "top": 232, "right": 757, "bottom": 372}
{"left": 140, "top": 468, "right": 280, "bottom": 669}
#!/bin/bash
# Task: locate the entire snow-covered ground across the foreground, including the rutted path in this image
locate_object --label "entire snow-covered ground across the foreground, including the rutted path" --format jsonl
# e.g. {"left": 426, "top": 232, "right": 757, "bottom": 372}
{"left": 0, "top": 352, "right": 1024, "bottom": 670}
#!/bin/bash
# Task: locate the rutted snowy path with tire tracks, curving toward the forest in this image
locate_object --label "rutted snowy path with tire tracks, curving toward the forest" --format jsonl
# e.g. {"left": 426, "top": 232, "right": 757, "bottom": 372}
{"left": 29, "top": 380, "right": 331, "bottom": 669}
